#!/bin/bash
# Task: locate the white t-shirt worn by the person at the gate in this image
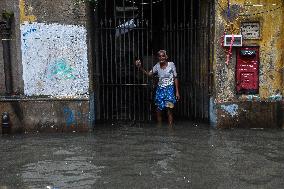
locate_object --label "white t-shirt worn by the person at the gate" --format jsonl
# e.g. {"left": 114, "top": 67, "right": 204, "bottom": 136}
{"left": 150, "top": 62, "right": 177, "bottom": 87}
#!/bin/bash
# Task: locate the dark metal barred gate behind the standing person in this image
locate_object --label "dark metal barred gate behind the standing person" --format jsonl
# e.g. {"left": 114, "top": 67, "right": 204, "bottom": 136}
{"left": 95, "top": 0, "right": 213, "bottom": 121}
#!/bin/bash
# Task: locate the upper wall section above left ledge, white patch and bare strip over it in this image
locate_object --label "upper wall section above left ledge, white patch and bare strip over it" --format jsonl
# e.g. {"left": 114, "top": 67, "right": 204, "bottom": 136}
{"left": 20, "top": 0, "right": 89, "bottom": 96}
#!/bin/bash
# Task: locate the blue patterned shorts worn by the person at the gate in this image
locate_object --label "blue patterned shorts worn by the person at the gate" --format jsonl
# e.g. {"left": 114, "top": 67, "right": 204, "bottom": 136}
{"left": 155, "top": 85, "right": 176, "bottom": 110}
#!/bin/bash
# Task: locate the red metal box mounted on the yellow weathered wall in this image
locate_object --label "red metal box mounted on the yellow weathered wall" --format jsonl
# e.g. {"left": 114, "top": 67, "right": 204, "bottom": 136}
{"left": 236, "top": 47, "right": 259, "bottom": 94}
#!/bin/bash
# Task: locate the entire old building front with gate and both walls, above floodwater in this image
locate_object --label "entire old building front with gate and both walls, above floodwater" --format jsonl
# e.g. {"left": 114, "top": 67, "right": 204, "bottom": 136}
{"left": 0, "top": 0, "right": 284, "bottom": 132}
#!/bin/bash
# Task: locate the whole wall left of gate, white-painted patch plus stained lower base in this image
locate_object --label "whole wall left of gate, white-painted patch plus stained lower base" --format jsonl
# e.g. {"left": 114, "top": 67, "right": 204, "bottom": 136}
{"left": 0, "top": 0, "right": 93, "bottom": 132}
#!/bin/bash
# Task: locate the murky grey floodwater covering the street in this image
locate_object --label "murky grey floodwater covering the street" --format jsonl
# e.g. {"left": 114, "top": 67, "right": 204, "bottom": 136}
{"left": 0, "top": 122, "right": 284, "bottom": 189}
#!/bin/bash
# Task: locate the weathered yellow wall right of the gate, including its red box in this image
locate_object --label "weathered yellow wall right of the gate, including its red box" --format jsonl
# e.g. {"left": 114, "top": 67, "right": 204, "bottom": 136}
{"left": 212, "top": 0, "right": 284, "bottom": 127}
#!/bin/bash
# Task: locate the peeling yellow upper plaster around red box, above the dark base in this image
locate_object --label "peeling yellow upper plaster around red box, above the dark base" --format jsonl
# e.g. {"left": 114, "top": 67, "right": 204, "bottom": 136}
{"left": 215, "top": 0, "right": 284, "bottom": 101}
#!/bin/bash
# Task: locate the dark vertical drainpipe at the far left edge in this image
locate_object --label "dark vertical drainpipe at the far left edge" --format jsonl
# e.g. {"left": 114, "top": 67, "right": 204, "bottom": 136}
{"left": 0, "top": 20, "right": 13, "bottom": 95}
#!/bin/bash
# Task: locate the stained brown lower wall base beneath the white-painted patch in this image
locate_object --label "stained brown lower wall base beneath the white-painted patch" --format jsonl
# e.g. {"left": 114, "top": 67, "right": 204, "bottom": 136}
{"left": 0, "top": 98, "right": 92, "bottom": 132}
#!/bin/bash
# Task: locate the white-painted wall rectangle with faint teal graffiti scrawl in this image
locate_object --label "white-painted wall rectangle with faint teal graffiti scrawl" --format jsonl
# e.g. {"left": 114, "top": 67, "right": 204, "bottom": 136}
{"left": 21, "top": 22, "right": 89, "bottom": 96}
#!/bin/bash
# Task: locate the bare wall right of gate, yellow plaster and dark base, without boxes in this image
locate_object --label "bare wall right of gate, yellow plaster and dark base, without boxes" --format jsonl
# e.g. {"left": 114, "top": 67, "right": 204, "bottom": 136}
{"left": 211, "top": 0, "right": 284, "bottom": 127}
